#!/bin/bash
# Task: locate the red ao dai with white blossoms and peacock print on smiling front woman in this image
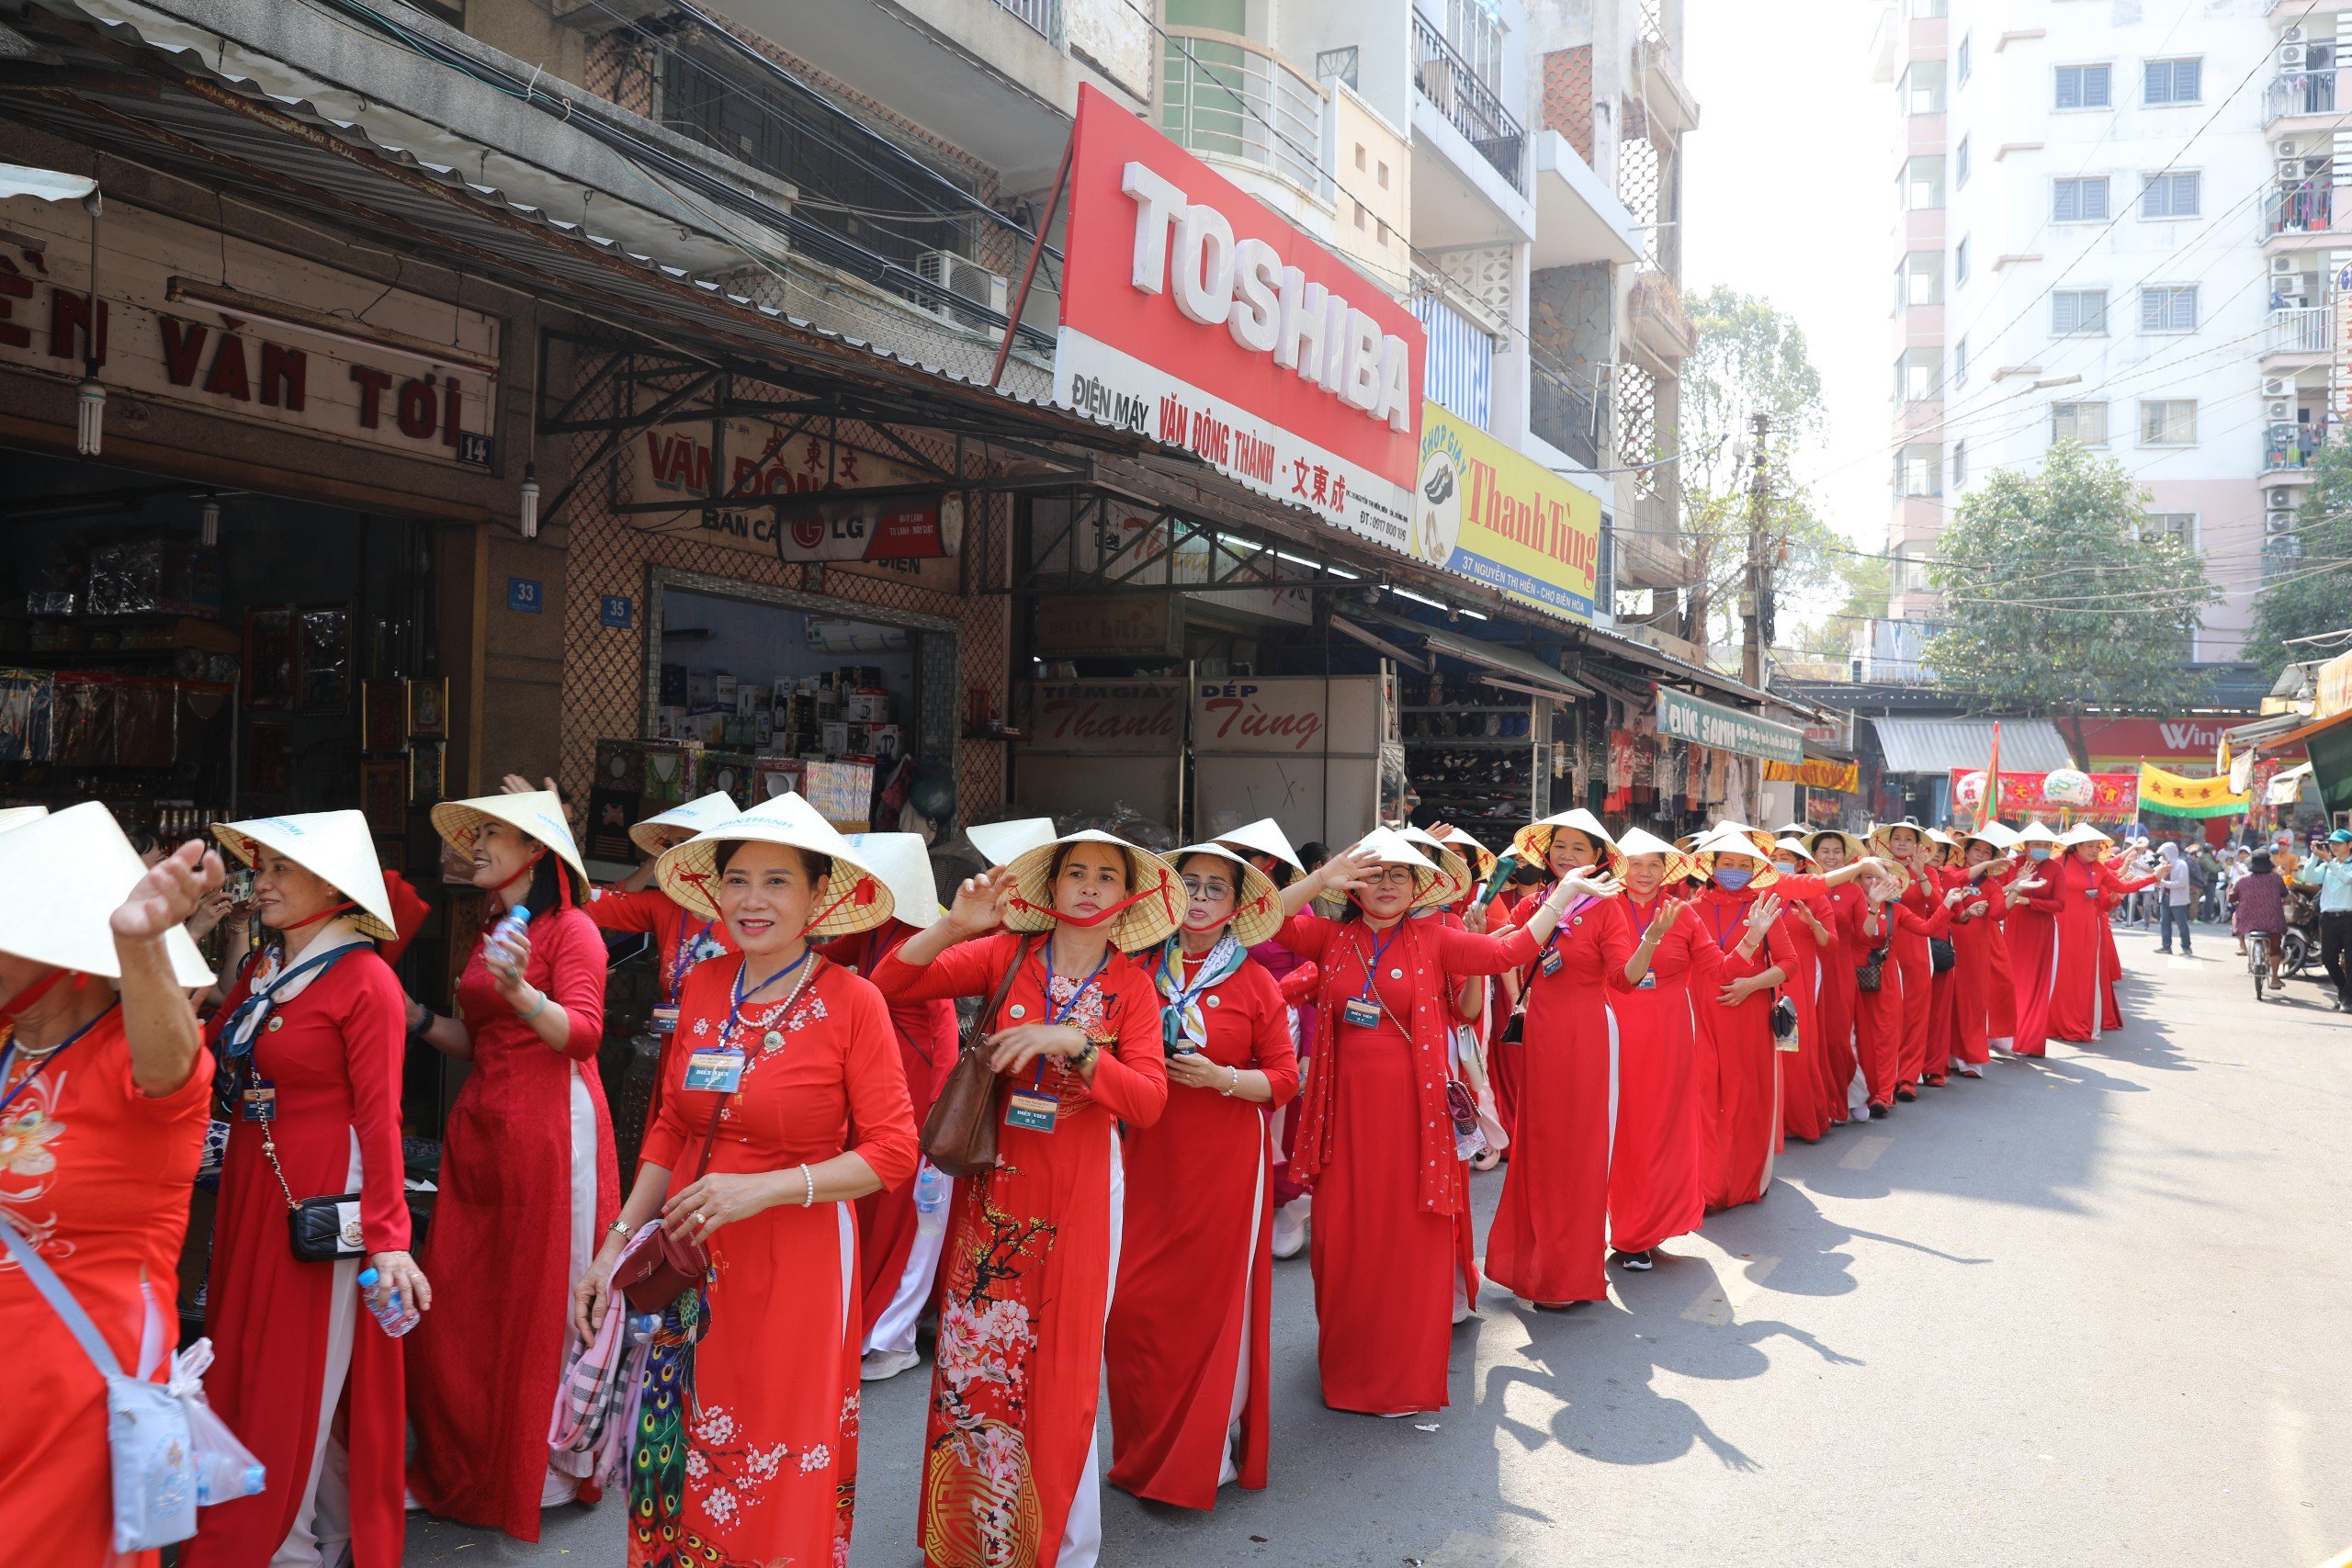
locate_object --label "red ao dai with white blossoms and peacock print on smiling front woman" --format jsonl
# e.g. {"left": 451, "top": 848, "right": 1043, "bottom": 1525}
{"left": 628, "top": 954, "right": 915, "bottom": 1568}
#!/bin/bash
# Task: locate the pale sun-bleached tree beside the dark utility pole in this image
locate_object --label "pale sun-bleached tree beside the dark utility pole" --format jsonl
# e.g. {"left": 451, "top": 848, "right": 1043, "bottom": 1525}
{"left": 1677, "top": 285, "right": 1837, "bottom": 644}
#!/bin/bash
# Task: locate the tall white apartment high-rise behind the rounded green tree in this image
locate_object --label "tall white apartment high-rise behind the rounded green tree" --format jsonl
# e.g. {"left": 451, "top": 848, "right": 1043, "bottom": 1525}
{"left": 1856, "top": 0, "right": 2338, "bottom": 677}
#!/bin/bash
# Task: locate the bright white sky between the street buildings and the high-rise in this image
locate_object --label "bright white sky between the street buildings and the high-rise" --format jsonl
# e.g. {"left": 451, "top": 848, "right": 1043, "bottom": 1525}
{"left": 1681, "top": 0, "right": 1895, "bottom": 639}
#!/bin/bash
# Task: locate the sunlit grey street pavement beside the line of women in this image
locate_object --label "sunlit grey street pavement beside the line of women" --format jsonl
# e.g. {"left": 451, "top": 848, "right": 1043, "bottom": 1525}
{"left": 407, "top": 926, "right": 2352, "bottom": 1568}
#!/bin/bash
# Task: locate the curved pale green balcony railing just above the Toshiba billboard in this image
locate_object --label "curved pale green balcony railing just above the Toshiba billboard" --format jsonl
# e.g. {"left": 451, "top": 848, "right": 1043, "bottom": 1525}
{"left": 1166, "top": 27, "right": 1331, "bottom": 202}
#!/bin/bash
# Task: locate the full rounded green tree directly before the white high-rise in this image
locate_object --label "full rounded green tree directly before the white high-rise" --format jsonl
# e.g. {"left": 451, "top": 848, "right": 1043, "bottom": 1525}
{"left": 1927, "top": 442, "right": 2221, "bottom": 766}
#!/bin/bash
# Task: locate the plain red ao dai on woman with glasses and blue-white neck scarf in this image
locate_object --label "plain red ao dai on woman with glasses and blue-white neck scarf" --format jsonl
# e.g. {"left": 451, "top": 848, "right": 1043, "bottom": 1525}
{"left": 1103, "top": 959, "right": 1298, "bottom": 1509}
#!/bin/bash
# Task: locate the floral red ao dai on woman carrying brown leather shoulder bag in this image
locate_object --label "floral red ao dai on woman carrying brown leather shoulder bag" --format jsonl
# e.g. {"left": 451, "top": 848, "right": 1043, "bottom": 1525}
{"left": 875, "top": 931, "right": 1169, "bottom": 1568}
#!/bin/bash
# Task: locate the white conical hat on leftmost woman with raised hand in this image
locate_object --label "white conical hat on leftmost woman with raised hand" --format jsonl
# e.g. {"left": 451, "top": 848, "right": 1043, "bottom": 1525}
{"left": 0, "top": 799, "right": 211, "bottom": 989}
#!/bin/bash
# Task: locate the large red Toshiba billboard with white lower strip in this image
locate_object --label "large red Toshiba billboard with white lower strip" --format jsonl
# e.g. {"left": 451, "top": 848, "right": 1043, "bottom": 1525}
{"left": 1054, "top": 87, "right": 1428, "bottom": 550}
